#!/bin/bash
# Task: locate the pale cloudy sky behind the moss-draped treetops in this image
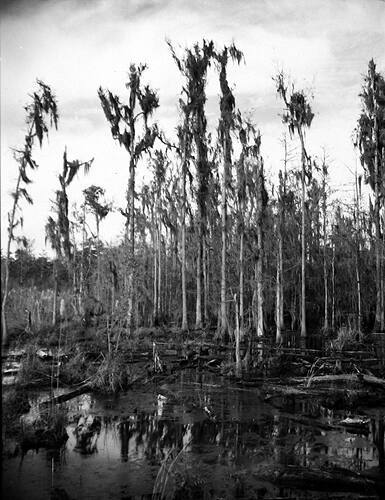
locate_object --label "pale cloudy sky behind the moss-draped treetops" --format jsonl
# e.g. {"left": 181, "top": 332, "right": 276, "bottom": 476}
{"left": 0, "top": 0, "right": 385, "bottom": 252}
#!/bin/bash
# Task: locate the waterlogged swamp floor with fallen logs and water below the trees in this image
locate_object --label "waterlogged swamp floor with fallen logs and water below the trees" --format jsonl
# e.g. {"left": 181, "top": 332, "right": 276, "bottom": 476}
{"left": 2, "top": 325, "right": 385, "bottom": 499}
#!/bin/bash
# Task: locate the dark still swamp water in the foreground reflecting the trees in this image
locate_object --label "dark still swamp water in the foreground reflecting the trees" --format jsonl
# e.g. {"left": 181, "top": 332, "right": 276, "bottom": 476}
{"left": 2, "top": 371, "right": 384, "bottom": 500}
